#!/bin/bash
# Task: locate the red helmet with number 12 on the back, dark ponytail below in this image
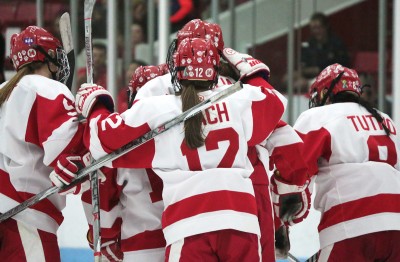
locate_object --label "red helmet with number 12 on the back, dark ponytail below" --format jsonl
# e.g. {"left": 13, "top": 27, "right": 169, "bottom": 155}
{"left": 173, "top": 38, "right": 220, "bottom": 89}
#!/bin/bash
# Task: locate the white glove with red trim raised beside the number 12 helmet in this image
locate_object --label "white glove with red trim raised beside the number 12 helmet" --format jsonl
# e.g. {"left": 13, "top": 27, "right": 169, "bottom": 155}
{"left": 222, "top": 48, "right": 270, "bottom": 81}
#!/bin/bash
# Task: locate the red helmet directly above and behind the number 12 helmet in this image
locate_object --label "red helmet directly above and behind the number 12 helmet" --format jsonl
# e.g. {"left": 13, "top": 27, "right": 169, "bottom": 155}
{"left": 176, "top": 19, "right": 224, "bottom": 52}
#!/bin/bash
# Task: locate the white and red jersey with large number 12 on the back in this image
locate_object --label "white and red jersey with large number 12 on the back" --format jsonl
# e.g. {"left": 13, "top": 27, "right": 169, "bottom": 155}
{"left": 85, "top": 81, "right": 286, "bottom": 245}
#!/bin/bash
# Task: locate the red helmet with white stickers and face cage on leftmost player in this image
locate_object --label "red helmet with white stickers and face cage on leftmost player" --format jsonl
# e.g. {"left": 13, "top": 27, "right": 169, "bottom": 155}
{"left": 10, "top": 26, "right": 70, "bottom": 82}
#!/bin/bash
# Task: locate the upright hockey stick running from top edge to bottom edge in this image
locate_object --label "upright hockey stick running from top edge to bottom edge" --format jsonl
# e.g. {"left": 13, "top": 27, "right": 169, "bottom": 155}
{"left": 84, "top": 0, "right": 101, "bottom": 262}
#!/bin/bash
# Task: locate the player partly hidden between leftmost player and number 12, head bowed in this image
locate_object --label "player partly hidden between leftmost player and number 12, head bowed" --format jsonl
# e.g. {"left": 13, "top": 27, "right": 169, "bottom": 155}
{"left": 82, "top": 65, "right": 168, "bottom": 262}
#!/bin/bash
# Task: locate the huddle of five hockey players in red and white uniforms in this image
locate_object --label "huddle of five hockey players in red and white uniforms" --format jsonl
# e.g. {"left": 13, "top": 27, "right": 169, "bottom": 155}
{"left": 0, "top": 19, "right": 400, "bottom": 262}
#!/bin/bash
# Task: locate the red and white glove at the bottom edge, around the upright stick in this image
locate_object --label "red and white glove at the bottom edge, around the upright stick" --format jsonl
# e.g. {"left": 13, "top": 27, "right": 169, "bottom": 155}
{"left": 87, "top": 229, "right": 124, "bottom": 262}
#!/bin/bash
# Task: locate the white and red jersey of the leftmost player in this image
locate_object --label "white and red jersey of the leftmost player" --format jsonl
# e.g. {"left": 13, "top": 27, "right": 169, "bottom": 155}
{"left": 0, "top": 75, "right": 83, "bottom": 233}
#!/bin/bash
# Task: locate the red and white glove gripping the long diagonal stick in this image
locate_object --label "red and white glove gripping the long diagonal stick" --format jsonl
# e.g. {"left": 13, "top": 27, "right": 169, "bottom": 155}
{"left": 49, "top": 153, "right": 106, "bottom": 195}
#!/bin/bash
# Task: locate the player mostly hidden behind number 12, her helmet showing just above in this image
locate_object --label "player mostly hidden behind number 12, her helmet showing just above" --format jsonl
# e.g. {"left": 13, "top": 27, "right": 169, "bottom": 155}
{"left": 139, "top": 19, "right": 310, "bottom": 262}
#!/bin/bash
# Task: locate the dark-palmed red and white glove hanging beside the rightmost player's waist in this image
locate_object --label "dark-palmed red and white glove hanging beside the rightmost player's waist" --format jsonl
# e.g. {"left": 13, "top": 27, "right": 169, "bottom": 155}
{"left": 271, "top": 173, "right": 311, "bottom": 225}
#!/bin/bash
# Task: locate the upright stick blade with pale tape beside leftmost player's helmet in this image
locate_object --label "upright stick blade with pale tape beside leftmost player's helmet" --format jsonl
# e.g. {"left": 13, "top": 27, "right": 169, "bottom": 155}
{"left": 60, "top": 12, "right": 75, "bottom": 90}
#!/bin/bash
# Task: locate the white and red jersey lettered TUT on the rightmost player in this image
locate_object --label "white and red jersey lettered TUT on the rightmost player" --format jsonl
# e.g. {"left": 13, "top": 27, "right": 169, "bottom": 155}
{"left": 294, "top": 103, "right": 400, "bottom": 249}
